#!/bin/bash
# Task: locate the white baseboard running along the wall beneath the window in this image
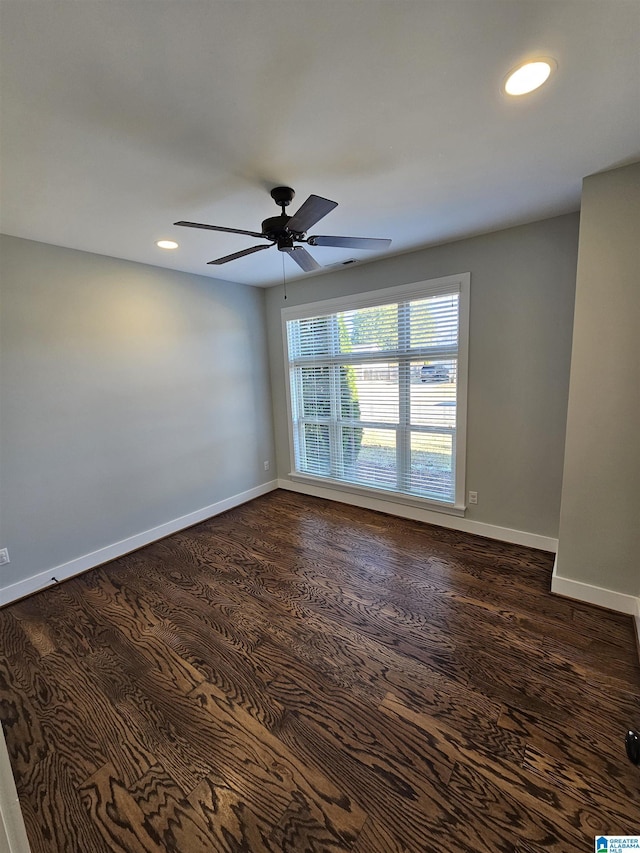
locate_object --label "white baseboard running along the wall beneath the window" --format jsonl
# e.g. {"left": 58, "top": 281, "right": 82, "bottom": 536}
{"left": 278, "top": 479, "right": 558, "bottom": 553}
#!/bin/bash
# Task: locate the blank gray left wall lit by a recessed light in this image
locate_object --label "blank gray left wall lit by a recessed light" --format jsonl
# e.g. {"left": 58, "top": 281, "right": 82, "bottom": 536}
{"left": 0, "top": 237, "right": 274, "bottom": 587}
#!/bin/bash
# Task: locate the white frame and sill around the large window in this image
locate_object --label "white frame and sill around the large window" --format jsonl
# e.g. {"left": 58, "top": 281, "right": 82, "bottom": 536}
{"left": 281, "top": 273, "right": 471, "bottom": 516}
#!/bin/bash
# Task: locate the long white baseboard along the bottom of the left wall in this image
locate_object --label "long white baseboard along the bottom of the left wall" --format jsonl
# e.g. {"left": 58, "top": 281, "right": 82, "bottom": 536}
{"left": 0, "top": 480, "right": 278, "bottom": 606}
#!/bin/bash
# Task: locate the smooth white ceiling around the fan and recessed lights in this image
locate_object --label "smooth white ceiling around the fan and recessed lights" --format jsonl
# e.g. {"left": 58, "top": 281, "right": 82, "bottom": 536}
{"left": 0, "top": 0, "right": 640, "bottom": 286}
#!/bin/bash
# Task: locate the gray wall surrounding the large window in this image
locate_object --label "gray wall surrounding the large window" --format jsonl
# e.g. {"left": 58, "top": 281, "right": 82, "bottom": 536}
{"left": 267, "top": 214, "right": 579, "bottom": 538}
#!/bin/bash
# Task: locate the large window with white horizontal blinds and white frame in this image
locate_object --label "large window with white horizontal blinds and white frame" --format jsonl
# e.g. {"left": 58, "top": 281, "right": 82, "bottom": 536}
{"left": 282, "top": 274, "right": 470, "bottom": 510}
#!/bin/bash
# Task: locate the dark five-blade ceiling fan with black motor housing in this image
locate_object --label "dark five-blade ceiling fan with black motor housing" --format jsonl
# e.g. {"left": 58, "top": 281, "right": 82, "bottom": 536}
{"left": 178, "top": 187, "right": 391, "bottom": 272}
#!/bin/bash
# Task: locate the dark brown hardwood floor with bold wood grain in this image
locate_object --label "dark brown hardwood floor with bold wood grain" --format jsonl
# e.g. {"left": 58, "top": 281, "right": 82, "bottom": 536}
{"left": 0, "top": 491, "right": 640, "bottom": 853}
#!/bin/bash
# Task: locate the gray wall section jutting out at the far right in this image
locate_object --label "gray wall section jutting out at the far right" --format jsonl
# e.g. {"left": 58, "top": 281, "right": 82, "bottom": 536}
{"left": 557, "top": 164, "right": 640, "bottom": 596}
